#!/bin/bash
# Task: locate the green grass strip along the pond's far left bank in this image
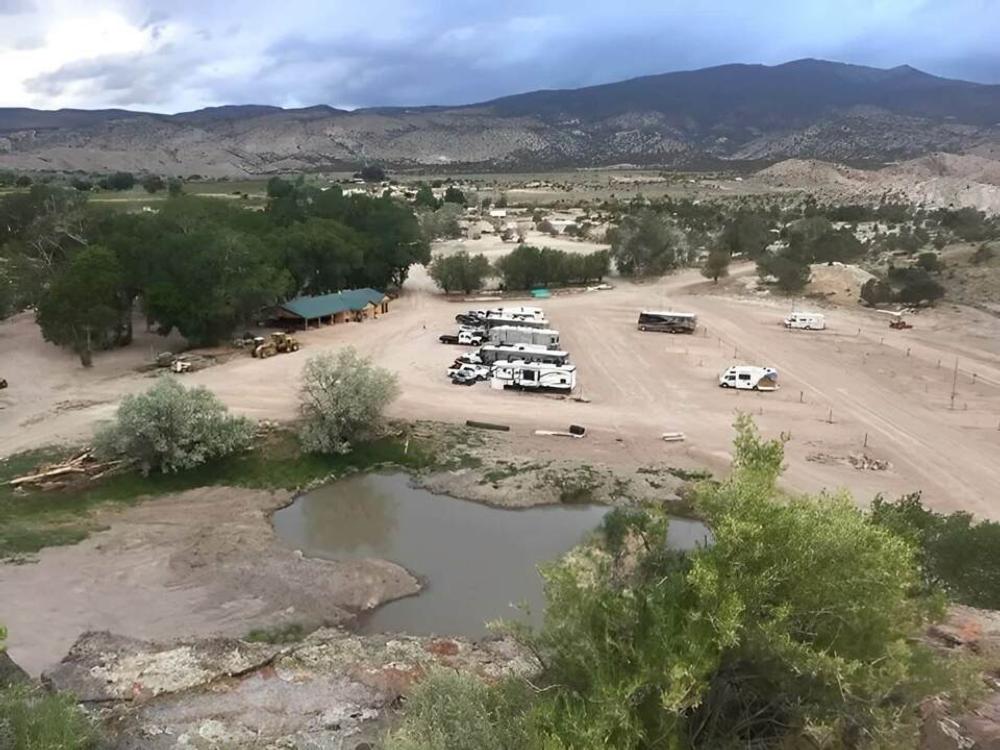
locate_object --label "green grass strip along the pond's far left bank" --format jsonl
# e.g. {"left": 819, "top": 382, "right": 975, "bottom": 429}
{"left": 0, "top": 431, "right": 434, "bottom": 559}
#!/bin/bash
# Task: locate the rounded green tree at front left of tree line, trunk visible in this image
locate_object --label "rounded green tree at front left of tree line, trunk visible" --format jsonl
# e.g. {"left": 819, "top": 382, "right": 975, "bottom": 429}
{"left": 37, "top": 245, "right": 123, "bottom": 367}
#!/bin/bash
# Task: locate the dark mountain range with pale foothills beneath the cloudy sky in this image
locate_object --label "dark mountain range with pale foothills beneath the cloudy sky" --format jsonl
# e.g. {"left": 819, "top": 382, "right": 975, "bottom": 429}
{"left": 0, "top": 59, "right": 1000, "bottom": 176}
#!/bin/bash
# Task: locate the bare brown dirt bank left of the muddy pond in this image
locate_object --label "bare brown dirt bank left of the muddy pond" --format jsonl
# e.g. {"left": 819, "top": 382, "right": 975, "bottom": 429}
{"left": 0, "top": 487, "right": 420, "bottom": 674}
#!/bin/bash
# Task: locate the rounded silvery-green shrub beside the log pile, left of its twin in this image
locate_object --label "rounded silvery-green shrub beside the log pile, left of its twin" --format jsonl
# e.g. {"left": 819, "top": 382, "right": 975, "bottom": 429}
{"left": 95, "top": 377, "right": 254, "bottom": 474}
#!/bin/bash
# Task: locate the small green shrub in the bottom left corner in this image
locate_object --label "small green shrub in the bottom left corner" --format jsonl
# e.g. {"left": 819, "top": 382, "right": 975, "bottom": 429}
{"left": 0, "top": 685, "right": 99, "bottom": 750}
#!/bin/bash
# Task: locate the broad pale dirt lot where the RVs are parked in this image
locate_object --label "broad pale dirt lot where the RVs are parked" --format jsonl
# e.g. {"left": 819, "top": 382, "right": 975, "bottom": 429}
{"left": 0, "top": 262, "right": 1000, "bottom": 518}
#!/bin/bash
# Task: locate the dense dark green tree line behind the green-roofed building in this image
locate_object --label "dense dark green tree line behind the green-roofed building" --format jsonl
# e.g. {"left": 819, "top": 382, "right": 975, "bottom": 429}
{"left": 0, "top": 178, "right": 430, "bottom": 365}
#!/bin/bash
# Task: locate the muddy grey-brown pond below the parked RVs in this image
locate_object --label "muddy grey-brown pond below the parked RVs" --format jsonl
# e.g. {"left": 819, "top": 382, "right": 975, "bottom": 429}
{"left": 274, "top": 473, "right": 707, "bottom": 638}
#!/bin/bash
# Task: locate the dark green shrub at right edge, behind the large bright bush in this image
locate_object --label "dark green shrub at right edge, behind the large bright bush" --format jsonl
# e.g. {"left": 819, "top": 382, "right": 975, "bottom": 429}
{"left": 871, "top": 493, "right": 1000, "bottom": 609}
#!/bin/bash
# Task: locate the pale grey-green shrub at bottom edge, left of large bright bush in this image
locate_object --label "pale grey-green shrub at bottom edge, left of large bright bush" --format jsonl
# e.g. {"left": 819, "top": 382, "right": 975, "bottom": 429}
{"left": 386, "top": 670, "right": 538, "bottom": 750}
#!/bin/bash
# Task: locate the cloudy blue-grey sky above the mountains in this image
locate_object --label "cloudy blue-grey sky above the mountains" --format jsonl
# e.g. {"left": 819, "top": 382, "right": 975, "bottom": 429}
{"left": 0, "top": 0, "right": 1000, "bottom": 112}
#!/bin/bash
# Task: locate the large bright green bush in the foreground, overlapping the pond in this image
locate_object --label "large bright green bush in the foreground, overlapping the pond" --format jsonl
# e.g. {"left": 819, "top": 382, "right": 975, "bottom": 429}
{"left": 390, "top": 417, "right": 974, "bottom": 750}
